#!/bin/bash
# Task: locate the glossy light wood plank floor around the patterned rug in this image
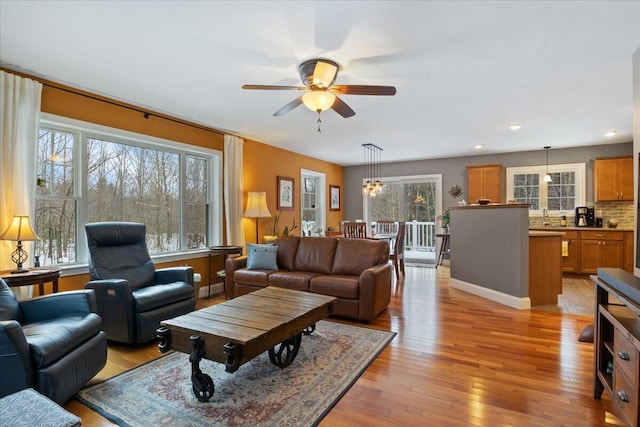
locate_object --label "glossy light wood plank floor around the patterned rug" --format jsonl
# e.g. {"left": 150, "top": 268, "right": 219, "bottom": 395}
{"left": 65, "top": 267, "right": 622, "bottom": 427}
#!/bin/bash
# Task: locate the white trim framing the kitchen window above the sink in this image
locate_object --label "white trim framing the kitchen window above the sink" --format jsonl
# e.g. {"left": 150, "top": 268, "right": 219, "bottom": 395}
{"left": 507, "top": 163, "right": 587, "bottom": 217}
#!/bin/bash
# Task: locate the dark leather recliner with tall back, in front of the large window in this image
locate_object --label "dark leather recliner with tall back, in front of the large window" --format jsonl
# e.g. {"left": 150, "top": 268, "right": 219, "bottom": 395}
{"left": 85, "top": 222, "right": 196, "bottom": 343}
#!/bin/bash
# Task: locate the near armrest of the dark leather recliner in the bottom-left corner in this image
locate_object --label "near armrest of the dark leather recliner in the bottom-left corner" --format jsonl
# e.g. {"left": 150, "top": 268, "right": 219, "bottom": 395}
{"left": 0, "top": 320, "right": 33, "bottom": 397}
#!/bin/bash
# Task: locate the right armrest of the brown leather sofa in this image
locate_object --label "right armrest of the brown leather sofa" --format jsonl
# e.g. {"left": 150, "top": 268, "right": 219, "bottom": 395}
{"left": 358, "top": 263, "right": 393, "bottom": 322}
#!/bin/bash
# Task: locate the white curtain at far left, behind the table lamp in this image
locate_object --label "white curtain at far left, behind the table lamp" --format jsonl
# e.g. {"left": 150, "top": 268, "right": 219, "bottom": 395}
{"left": 0, "top": 71, "right": 42, "bottom": 296}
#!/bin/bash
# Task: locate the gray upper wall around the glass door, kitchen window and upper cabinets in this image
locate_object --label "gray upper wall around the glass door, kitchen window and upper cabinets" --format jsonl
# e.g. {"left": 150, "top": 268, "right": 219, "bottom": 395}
{"left": 342, "top": 142, "right": 633, "bottom": 219}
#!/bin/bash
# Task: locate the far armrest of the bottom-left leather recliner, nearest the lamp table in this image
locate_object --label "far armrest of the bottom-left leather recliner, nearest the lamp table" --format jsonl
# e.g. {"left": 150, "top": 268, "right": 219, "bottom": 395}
{"left": 19, "top": 289, "right": 97, "bottom": 323}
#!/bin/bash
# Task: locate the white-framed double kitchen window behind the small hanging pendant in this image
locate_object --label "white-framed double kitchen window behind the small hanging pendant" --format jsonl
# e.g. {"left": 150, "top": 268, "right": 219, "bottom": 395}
{"left": 507, "top": 163, "right": 586, "bottom": 215}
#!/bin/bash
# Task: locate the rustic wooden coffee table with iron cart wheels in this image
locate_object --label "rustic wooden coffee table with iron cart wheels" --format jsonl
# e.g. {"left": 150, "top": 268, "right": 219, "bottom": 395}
{"left": 157, "top": 287, "right": 336, "bottom": 402}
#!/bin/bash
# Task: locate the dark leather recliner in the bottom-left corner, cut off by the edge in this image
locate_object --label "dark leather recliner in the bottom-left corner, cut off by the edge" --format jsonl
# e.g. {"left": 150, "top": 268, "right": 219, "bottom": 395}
{"left": 0, "top": 279, "right": 107, "bottom": 404}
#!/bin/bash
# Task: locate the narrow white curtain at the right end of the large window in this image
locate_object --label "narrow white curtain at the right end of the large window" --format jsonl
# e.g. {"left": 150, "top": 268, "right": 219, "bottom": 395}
{"left": 224, "top": 135, "right": 244, "bottom": 246}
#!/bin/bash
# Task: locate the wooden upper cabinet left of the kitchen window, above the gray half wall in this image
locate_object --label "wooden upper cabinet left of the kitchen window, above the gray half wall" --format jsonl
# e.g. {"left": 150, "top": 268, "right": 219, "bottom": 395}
{"left": 467, "top": 165, "right": 506, "bottom": 203}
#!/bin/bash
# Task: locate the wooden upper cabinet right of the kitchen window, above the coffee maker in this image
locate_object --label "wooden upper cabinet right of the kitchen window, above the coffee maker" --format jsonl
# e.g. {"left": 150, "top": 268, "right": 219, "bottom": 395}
{"left": 593, "top": 156, "right": 633, "bottom": 202}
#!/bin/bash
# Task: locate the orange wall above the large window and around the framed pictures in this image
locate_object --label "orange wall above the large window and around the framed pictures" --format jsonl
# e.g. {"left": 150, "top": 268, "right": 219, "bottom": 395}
{"left": 0, "top": 67, "right": 343, "bottom": 290}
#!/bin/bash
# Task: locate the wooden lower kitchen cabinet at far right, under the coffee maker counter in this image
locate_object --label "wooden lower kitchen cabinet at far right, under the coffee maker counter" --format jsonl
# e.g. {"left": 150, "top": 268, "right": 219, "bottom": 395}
{"left": 580, "top": 231, "right": 624, "bottom": 274}
